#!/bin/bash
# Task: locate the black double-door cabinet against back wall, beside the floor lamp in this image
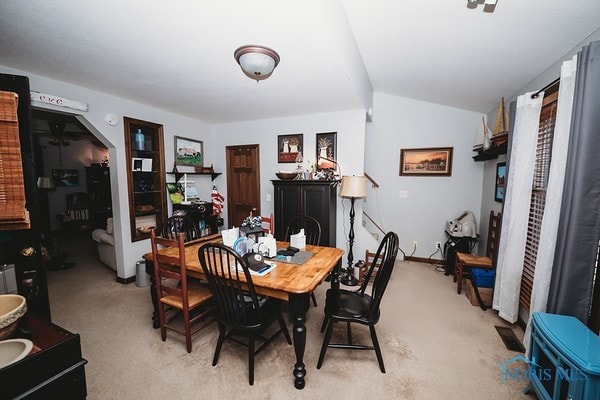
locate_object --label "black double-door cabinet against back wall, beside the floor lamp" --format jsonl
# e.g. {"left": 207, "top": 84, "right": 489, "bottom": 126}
{"left": 271, "top": 180, "right": 337, "bottom": 247}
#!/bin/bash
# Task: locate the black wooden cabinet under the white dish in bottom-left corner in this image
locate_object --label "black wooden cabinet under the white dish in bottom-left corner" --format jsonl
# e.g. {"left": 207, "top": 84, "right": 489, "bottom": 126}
{"left": 0, "top": 313, "right": 87, "bottom": 399}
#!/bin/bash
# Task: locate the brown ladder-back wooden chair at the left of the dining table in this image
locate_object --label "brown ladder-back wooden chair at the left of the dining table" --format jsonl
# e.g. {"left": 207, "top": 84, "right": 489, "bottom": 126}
{"left": 150, "top": 229, "right": 214, "bottom": 353}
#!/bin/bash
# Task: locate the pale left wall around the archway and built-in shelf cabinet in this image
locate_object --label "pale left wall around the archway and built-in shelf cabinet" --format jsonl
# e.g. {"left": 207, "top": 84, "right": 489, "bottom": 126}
{"left": 0, "top": 65, "right": 214, "bottom": 279}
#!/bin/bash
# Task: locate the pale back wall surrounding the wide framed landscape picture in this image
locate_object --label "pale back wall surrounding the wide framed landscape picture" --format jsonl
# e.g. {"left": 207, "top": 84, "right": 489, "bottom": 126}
{"left": 364, "top": 93, "right": 483, "bottom": 259}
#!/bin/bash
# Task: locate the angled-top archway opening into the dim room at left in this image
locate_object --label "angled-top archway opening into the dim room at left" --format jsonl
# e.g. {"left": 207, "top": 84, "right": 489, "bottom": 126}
{"left": 31, "top": 108, "right": 112, "bottom": 269}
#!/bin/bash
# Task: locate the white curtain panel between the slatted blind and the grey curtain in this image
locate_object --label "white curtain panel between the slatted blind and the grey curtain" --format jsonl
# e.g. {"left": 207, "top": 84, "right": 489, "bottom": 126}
{"left": 524, "top": 56, "right": 577, "bottom": 348}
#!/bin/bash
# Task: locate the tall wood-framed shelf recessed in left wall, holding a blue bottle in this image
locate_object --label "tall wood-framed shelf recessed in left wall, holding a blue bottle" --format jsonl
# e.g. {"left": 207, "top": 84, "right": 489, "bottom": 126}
{"left": 123, "top": 117, "right": 167, "bottom": 242}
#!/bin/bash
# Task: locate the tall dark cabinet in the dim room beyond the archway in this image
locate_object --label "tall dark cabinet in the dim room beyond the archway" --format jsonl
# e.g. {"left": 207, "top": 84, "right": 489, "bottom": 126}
{"left": 85, "top": 165, "right": 112, "bottom": 229}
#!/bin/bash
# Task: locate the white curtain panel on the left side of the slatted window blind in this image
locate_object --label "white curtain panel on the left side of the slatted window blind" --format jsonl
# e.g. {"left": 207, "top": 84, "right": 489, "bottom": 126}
{"left": 493, "top": 92, "right": 544, "bottom": 323}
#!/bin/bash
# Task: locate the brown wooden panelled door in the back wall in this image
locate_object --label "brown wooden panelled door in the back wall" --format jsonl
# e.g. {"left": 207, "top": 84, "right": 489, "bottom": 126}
{"left": 226, "top": 144, "right": 260, "bottom": 228}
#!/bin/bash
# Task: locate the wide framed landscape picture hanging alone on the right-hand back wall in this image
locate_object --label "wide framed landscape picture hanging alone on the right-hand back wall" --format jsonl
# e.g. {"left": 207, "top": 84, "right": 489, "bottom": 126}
{"left": 400, "top": 147, "right": 453, "bottom": 176}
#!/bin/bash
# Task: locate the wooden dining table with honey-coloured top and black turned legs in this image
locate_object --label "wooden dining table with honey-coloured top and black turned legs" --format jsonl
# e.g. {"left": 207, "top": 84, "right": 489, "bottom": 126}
{"left": 144, "top": 234, "right": 344, "bottom": 389}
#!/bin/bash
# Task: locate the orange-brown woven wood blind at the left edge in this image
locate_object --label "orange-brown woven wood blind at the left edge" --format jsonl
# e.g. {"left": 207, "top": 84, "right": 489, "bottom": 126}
{"left": 0, "top": 91, "right": 30, "bottom": 230}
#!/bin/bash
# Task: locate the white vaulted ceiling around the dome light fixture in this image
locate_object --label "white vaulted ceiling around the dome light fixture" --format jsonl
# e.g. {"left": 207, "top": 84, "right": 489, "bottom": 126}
{"left": 0, "top": 0, "right": 600, "bottom": 123}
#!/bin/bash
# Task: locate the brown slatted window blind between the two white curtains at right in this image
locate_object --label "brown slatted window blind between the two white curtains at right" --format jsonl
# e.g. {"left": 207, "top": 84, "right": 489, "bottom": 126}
{"left": 519, "top": 88, "right": 558, "bottom": 310}
